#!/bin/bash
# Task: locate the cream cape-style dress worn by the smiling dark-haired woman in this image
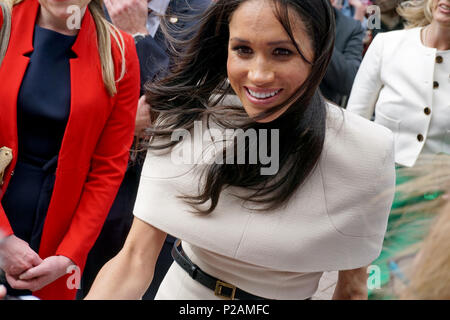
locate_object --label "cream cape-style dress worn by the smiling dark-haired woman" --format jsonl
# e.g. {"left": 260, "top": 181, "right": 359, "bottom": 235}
{"left": 134, "top": 105, "right": 395, "bottom": 299}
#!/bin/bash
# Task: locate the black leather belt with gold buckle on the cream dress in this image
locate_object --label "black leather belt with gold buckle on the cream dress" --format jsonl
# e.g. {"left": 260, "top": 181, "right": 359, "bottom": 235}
{"left": 172, "top": 239, "right": 268, "bottom": 300}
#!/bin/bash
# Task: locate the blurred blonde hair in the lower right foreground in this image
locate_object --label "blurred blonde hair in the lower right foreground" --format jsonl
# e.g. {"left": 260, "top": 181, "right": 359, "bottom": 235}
{"left": 394, "top": 154, "right": 450, "bottom": 300}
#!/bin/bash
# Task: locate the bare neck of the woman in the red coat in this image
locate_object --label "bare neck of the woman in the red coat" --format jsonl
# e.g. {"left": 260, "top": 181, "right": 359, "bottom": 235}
{"left": 39, "top": 0, "right": 91, "bottom": 31}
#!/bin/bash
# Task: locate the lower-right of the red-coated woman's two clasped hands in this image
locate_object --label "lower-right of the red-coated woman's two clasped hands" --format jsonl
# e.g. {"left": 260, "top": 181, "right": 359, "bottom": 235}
{"left": 6, "top": 256, "right": 74, "bottom": 291}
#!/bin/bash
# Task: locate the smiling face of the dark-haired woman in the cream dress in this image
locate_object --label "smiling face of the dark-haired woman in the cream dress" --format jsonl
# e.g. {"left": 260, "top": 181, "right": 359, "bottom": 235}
{"left": 227, "top": 0, "right": 314, "bottom": 122}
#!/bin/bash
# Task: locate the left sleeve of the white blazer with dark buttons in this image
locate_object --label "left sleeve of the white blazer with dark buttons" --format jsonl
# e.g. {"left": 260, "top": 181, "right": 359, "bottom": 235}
{"left": 347, "top": 34, "right": 384, "bottom": 119}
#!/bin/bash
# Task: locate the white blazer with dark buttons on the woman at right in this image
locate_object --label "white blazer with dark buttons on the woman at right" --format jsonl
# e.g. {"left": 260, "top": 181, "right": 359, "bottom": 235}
{"left": 347, "top": 28, "right": 450, "bottom": 167}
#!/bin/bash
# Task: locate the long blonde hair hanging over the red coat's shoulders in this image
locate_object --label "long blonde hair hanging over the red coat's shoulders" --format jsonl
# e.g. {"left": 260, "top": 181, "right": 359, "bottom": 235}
{"left": 0, "top": 0, "right": 126, "bottom": 96}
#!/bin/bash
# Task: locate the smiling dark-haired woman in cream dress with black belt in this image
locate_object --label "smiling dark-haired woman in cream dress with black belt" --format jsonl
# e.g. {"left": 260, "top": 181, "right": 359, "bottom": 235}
{"left": 87, "top": 0, "right": 394, "bottom": 300}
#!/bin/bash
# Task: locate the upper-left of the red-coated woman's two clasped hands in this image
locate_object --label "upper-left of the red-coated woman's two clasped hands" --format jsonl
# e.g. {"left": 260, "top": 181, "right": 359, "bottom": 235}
{"left": 0, "top": 235, "right": 42, "bottom": 276}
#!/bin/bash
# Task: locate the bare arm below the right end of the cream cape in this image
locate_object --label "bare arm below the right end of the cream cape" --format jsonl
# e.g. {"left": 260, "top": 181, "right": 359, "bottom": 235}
{"left": 333, "top": 267, "right": 368, "bottom": 300}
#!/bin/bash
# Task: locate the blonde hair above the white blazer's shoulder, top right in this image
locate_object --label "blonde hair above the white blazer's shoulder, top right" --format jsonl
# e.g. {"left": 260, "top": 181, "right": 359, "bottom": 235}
{"left": 397, "top": 0, "right": 434, "bottom": 29}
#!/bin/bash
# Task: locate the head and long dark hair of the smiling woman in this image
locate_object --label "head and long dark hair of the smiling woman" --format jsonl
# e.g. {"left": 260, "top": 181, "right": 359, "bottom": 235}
{"left": 142, "top": 0, "right": 334, "bottom": 213}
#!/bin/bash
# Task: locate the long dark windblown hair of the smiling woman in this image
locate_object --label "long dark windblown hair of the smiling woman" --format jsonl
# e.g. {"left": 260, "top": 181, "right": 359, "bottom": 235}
{"left": 146, "top": 0, "right": 335, "bottom": 214}
